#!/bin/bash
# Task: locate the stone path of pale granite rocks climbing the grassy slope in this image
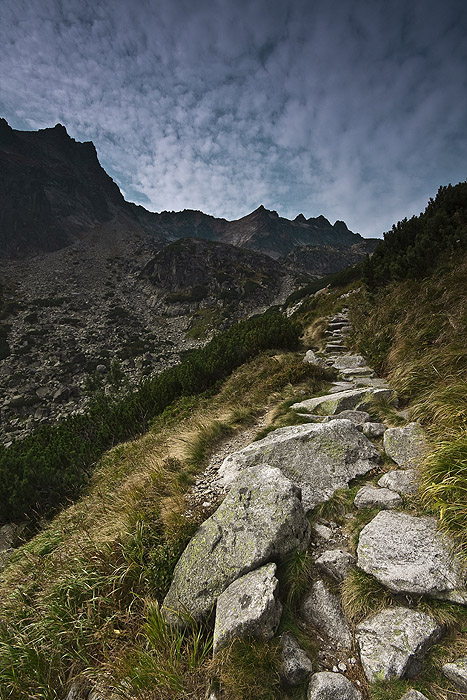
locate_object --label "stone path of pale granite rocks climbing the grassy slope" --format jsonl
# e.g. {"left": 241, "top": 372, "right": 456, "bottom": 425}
{"left": 158, "top": 312, "right": 467, "bottom": 700}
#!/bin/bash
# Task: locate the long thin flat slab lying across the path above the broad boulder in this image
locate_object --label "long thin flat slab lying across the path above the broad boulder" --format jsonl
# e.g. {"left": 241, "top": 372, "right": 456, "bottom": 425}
{"left": 291, "top": 387, "right": 395, "bottom": 416}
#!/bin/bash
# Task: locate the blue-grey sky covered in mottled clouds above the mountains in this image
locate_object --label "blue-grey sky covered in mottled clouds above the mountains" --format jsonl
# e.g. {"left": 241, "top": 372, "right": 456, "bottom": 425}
{"left": 0, "top": 0, "right": 467, "bottom": 237}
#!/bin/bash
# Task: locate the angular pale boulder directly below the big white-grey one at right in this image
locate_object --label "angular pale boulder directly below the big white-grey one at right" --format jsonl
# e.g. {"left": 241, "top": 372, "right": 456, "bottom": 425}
{"left": 356, "top": 607, "right": 442, "bottom": 682}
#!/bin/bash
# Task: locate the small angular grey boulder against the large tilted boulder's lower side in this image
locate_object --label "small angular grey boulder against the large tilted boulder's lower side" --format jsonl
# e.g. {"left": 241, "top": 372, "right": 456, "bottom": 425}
{"left": 213, "top": 564, "right": 282, "bottom": 654}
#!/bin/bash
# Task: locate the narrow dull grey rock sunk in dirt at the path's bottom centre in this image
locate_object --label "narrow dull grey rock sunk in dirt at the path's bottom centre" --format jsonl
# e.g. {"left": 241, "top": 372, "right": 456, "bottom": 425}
{"left": 301, "top": 579, "right": 352, "bottom": 649}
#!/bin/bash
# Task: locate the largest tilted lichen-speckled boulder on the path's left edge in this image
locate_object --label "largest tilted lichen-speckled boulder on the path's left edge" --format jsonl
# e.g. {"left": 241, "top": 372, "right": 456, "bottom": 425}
{"left": 162, "top": 464, "right": 310, "bottom": 625}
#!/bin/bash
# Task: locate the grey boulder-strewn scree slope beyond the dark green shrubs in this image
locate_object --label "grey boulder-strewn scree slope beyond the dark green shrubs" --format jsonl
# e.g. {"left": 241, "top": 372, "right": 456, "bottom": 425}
{"left": 0, "top": 221, "right": 295, "bottom": 444}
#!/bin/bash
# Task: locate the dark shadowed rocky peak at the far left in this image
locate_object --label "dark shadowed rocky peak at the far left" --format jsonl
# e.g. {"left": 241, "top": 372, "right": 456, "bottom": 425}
{"left": 0, "top": 119, "right": 136, "bottom": 257}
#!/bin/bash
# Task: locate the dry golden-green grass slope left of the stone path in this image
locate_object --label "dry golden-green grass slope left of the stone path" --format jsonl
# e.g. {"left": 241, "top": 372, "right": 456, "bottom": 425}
{"left": 0, "top": 353, "right": 330, "bottom": 700}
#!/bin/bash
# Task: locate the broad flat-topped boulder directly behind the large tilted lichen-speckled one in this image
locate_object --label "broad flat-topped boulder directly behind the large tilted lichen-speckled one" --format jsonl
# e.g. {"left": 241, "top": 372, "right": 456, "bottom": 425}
{"left": 219, "top": 420, "right": 380, "bottom": 510}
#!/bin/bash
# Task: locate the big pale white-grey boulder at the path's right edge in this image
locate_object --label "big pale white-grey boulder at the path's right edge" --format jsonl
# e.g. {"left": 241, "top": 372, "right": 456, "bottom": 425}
{"left": 357, "top": 511, "right": 467, "bottom": 604}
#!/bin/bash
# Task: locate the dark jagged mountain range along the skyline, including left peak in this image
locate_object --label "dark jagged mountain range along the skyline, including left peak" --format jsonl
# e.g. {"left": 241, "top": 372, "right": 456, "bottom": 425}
{"left": 0, "top": 119, "right": 376, "bottom": 268}
